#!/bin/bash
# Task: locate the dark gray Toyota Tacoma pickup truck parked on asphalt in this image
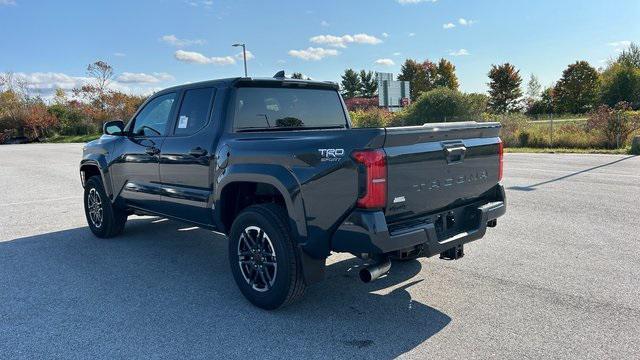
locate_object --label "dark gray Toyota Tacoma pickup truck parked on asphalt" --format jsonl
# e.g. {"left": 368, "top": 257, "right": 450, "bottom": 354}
{"left": 80, "top": 78, "right": 505, "bottom": 309}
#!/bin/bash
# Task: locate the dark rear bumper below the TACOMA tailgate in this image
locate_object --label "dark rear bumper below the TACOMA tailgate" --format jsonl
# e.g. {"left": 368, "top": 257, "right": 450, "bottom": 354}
{"left": 332, "top": 185, "right": 506, "bottom": 256}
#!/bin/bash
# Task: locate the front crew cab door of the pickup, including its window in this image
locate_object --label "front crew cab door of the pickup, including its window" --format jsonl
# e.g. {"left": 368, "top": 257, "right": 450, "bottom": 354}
{"left": 110, "top": 93, "right": 177, "bottom": 211}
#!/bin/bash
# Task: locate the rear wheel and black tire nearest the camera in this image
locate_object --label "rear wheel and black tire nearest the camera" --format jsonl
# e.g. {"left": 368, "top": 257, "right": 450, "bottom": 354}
{"left": 229, "top": 204, "right": 306, "bottom": 310}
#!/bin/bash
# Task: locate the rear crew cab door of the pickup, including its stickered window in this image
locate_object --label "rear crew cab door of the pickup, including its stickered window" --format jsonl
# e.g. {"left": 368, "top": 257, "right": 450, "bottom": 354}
{"left": 160, "top": 87, "right": 215, "bottom": 225}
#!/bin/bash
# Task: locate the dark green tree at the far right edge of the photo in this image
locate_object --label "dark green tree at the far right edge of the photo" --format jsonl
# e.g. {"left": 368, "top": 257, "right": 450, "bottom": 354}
{"left": 600, "top": 62, "right": 640, "bottom": 109}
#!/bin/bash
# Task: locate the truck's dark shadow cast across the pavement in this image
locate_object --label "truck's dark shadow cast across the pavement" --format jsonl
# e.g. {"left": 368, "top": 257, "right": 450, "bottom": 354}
{"left": 0, "top": 218, "right": 451, "bottom": 358}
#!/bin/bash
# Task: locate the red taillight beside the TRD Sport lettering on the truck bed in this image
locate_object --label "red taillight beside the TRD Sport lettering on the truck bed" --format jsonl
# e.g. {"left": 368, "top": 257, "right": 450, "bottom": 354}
{"left": 351, "top": 150, "right": 387, "bottom": 209}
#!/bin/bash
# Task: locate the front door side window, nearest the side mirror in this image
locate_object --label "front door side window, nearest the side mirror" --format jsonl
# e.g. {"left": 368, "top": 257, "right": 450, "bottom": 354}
{"left": 132, "top": 93, "right": 176, "bottom": 136}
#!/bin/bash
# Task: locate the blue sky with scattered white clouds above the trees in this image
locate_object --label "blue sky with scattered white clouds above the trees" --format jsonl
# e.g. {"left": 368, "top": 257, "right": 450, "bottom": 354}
{"left": 0, "top": 0, "right": 640, "bottom": 95}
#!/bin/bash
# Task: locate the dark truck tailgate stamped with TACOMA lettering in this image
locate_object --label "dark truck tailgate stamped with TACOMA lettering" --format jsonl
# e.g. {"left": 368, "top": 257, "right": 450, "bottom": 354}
{"left": 384, "top": 122, "right": 501, "bottom": 223}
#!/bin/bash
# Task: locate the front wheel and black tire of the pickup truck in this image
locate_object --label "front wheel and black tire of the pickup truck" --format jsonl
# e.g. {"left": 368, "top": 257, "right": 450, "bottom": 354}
{"left": 84, "top": 176, "right": 127, "bottom": 238}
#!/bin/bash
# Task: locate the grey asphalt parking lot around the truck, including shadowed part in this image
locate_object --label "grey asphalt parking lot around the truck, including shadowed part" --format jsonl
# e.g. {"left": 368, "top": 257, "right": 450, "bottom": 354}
{"left": 0, "top": 144, "right": 640, "bottom": 359}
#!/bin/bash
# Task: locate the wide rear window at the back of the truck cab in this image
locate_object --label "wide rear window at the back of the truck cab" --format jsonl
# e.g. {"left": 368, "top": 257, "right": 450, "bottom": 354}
{"left": 234, "top": 87, "right": 347, "bottom": 131}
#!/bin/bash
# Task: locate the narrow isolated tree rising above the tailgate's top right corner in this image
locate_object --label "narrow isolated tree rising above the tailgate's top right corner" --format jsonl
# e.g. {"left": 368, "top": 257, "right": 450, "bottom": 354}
{"left": 488, "top": 63, "right": 522, "bottom": 114}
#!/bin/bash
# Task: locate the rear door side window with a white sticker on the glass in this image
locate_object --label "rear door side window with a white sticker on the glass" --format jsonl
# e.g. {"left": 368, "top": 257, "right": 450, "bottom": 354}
{"left": 173, "top": 88, "right": 213, "bottom": 135}
